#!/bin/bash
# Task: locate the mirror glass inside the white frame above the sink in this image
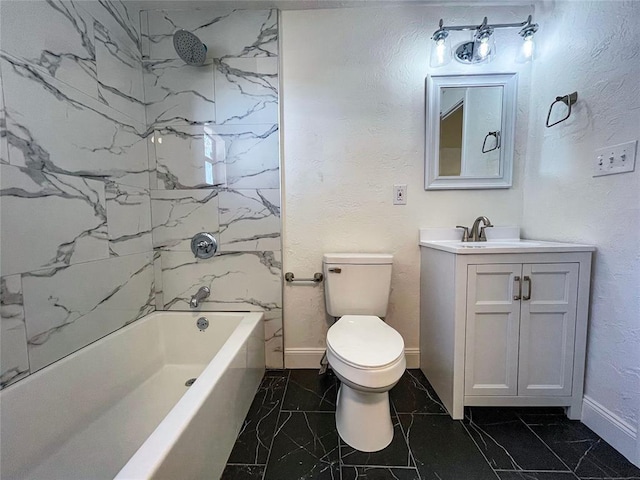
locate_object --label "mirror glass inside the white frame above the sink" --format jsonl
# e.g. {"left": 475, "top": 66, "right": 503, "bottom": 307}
{"left": 438, "top": 85, "right": 503, "bottom": 177}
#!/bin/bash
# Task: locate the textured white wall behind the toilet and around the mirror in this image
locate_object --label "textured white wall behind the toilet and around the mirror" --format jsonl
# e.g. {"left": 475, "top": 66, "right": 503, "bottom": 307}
{"left": 281, "top": 6, "right": 530, "bottom": 357}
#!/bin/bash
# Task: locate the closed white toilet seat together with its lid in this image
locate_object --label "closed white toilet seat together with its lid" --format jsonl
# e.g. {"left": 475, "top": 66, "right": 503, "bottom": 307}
{"left": 327, "top": 315, "right": 406, "bottom": 389}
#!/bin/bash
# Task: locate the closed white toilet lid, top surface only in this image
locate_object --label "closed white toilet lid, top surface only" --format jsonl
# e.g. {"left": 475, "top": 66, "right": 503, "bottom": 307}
{"left": 327, "top": 315, "right": 404, "bottom": 368}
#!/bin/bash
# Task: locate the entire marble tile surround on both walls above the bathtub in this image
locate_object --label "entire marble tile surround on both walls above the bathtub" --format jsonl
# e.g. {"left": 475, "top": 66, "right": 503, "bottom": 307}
{"left": 0, "top": 0, "right": 282, "bottom": 387}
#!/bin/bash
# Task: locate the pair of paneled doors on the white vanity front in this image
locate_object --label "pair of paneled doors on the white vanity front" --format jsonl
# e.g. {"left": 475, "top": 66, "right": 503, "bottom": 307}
{"left": 464, "top": 263, "right": 579, "bottom": 397}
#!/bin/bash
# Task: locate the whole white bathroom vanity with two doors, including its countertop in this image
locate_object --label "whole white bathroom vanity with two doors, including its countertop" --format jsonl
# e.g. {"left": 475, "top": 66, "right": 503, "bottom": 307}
{"left": 420, "top": 236, "right": 593, "bottom": 419}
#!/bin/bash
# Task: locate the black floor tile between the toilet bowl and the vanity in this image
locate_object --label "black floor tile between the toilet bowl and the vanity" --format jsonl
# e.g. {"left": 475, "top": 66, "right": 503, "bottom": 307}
{"left": 389, "top": 369, "right": 447, "bottom": 413}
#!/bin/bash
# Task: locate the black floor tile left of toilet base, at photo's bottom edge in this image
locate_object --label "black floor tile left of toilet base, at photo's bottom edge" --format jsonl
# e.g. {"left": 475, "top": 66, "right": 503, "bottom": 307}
{"left": 264, "top": 412, "right": 340, "bottom": 480}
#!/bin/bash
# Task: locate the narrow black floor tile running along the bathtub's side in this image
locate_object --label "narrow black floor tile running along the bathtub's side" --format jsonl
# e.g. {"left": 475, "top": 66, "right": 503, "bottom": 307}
{"left": 228, "top": 370, "right": 289, "bottom": 464}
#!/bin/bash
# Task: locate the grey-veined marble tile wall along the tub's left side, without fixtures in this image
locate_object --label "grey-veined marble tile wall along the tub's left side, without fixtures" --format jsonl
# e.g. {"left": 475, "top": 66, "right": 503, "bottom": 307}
{"left": 0, "top": 0, "right": 155, "bottom": 387}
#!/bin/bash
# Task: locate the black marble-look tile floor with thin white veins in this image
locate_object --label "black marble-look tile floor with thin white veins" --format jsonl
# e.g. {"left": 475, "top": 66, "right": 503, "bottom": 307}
{"left": 222, "top": 370, "right": 640, "bottom": 480}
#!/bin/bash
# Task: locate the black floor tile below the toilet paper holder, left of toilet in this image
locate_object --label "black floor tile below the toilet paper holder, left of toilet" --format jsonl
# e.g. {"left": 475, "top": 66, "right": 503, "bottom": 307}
{"left": 282, "top": 370, "right": 338, "bottom": 412}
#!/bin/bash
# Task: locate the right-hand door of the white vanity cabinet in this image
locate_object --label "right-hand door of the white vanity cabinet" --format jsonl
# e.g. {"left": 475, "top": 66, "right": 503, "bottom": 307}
{"left": 518, "top": 263, "right": 578, "bottom": 396}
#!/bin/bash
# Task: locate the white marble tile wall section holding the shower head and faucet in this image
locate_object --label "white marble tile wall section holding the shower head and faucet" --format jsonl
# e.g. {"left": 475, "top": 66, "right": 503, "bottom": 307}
{"left": 141, "top": 7, "right": 283, "bottom": 368}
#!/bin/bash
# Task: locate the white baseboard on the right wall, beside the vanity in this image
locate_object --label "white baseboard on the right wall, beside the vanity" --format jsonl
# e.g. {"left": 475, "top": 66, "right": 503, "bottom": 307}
{"left": 582, "top": 395, "right": 640, "bottom": 467}
